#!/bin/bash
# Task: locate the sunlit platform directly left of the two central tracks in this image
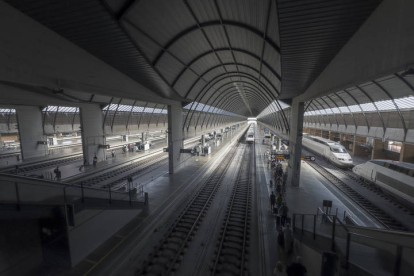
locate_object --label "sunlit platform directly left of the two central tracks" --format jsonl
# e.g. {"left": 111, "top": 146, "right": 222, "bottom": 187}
{"left": 16, "top": 128, "right": 247, "bottom": 275}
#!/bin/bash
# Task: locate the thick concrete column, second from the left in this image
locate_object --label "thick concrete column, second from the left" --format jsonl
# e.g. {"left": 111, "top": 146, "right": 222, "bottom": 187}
{"left": 79, "top": 104, "right": 106, "bottom": 164}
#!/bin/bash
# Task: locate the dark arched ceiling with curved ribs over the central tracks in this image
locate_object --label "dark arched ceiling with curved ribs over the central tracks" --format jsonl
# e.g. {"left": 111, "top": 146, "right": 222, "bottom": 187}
{"left": 6, "top": 0, "right": 381, "bottom": 117}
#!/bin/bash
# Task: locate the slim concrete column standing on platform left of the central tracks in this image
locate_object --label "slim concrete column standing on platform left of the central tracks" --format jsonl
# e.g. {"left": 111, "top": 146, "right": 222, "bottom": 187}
{"left": 168, "top": 105, "right": 183, "bottom": 174}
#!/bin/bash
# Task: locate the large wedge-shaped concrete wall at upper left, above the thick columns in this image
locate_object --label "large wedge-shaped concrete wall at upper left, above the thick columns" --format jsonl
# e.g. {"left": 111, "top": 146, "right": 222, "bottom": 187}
{"left": 0, "top": 1, "right": 176, "bottom": 105}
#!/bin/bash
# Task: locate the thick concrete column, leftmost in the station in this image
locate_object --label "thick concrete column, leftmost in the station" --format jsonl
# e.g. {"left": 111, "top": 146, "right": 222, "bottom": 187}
{"left": 16, "top": 106, "right": 48, "bottom": 160}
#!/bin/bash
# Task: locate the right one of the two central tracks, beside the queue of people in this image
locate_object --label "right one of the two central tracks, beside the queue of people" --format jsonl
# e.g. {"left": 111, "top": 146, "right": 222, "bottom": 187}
{"left": 211, "top": 145, "right": 253, "bottom": 276}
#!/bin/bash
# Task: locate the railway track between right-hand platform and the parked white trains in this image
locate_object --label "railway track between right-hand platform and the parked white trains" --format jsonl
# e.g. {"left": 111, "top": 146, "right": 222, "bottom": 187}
{"left": 306, "top": 158, "right": 408, "bottom": 231}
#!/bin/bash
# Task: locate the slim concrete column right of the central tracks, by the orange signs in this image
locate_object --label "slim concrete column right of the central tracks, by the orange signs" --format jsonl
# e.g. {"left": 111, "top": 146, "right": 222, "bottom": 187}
{"left": 288, "top": 100, "right": 304, "bottom": 186}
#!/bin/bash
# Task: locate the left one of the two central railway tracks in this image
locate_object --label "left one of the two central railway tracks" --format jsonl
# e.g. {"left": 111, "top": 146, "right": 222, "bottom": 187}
{"left": 135, "top": 137, "right": 243, "bottom": 276}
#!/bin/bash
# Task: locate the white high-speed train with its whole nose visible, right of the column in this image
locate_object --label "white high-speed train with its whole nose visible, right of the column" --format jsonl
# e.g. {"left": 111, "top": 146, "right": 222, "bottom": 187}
{"left": 302, "top": 134, "right": 353, "bottom": 168}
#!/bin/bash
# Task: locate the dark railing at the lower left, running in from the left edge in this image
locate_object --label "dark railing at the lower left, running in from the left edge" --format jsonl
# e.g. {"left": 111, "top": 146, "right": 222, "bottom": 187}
{"left": 0, "top": 174, "right": 147, "bottom": 210}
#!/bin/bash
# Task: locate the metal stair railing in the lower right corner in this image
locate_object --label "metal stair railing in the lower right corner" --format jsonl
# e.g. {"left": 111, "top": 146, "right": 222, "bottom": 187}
{"left": 292, "top": 208, "right": 414, "bottom": 276}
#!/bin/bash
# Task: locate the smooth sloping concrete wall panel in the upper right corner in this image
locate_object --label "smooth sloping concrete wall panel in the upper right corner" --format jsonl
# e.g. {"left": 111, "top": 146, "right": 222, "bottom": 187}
{"left": 298, "top": 0, "right": 414, "bottom": 101}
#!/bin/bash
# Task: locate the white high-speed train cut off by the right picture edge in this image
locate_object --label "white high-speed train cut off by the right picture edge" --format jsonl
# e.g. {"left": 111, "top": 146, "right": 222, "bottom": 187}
{"left": 352, "top": 159, "right": 414, "bottom": 204}
